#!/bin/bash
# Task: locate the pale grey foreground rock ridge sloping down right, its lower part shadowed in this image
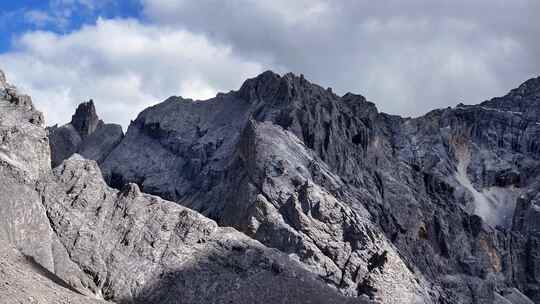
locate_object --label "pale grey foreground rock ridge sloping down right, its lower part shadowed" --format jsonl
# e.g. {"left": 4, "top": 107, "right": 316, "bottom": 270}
{"left": 43, "top": 155, "right": 361, "bottom": 303}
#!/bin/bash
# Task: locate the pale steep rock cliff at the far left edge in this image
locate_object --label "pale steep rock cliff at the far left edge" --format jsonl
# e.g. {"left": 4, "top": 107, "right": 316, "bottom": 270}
{"left": 0, "top": 74, "right": 98, "bottom": 293}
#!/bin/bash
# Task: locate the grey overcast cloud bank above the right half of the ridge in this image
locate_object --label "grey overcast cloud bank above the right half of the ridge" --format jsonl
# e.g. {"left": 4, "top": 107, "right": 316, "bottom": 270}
{"left": 142, "top": 0, "right": 540, "bottom": 115}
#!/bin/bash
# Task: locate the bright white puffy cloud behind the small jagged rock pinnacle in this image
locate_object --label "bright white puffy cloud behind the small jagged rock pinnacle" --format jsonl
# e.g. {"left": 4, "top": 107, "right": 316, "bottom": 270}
{"left": 0, "top": 19, "right": 262, "bottom": 127}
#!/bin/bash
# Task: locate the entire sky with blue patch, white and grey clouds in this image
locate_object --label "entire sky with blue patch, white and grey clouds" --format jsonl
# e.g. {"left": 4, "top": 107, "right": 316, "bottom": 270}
{"left": 0, "top": 0, "right": 540, "bottom": 127}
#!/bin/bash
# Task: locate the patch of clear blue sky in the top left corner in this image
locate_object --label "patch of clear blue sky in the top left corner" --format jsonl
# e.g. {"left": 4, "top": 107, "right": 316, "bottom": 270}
{"left": 0, "top": 0, "right": 141, "bottom": 52}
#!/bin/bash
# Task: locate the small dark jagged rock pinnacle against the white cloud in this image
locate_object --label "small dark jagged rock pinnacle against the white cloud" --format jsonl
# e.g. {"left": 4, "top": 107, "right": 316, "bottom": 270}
{"left": 47, "top": 100, "right": 124, "bottom": 167}
